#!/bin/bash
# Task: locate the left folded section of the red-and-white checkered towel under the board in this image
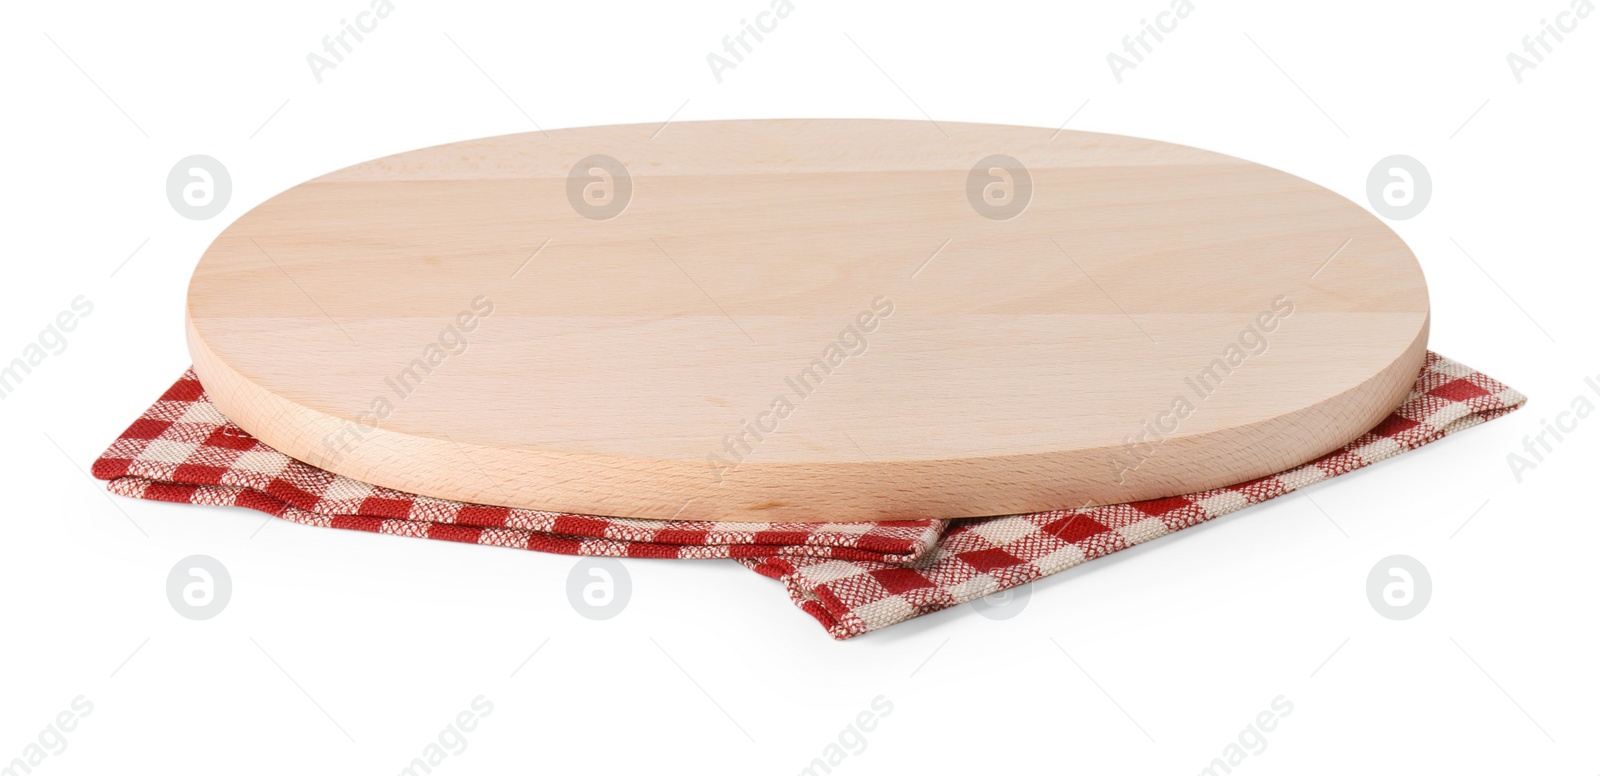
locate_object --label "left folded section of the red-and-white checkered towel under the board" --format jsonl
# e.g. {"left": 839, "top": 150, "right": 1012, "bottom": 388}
{"left": 93, "top": 370, "right": 944, "bottom": 562}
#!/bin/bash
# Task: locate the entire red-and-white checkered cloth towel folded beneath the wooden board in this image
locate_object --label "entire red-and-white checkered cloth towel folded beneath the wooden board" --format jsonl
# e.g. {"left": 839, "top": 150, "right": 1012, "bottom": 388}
{"left": 93, "top": 352, "right": 1526, "bottom": 638}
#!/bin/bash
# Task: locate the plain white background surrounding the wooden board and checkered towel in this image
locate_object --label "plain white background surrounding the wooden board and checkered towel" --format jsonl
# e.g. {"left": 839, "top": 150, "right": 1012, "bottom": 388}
{"left": 0, "top": 0, "right": 1600, "bottom": 774}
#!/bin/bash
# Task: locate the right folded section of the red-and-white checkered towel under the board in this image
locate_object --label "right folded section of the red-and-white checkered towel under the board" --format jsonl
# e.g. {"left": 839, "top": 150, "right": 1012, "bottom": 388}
{"left": 741, "top": 352, "right": 1526, "bottom": 638}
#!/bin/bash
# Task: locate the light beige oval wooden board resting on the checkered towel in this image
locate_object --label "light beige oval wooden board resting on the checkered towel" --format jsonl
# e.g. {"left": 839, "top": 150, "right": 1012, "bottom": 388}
{"left": 187, "top": 120, "right": 1429, "bottom": 522}
